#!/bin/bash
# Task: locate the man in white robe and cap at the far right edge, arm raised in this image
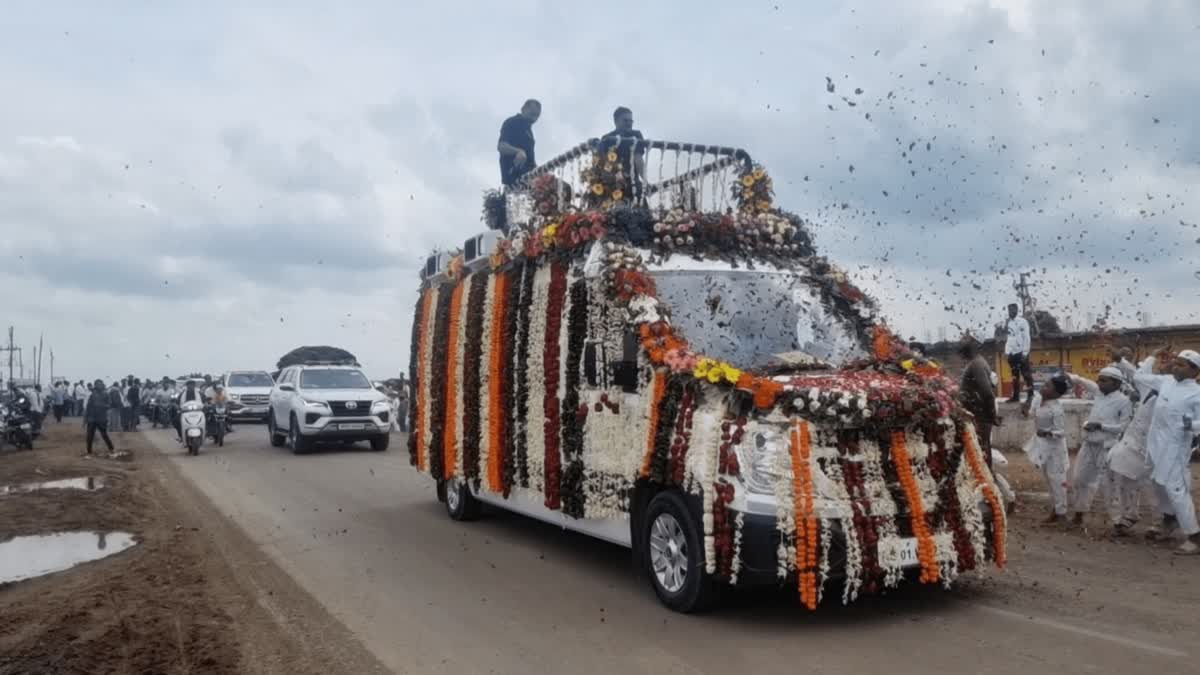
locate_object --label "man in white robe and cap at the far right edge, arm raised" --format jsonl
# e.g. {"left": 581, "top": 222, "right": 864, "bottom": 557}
{"left": 1135, "top": 350, "right": 1200, "bottom": 555}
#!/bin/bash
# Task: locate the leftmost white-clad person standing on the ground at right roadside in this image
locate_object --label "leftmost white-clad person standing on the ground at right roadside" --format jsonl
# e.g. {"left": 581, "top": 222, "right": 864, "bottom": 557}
{"left": 1021, "top": 372, "right": 1070, "bottom": 525}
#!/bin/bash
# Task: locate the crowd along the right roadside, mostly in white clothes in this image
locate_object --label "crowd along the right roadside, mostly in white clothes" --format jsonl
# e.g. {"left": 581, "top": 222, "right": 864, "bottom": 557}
{"left": 960, "top": 305, "right": 1200, "bottom": 555}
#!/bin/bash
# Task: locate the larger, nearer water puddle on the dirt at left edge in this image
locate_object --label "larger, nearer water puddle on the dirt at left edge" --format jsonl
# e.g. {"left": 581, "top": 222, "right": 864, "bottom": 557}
{"left": 0, "top": 532, "right": 137, "bottom": 584}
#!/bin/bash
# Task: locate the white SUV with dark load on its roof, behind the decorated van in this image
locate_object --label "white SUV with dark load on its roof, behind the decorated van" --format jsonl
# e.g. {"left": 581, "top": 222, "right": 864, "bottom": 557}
{"left": 266, "top": 365, "right": 392, "bottom": 454}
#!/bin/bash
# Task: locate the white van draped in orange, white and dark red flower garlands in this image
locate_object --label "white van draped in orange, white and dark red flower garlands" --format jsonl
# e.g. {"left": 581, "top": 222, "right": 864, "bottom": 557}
{"left": 408, "top": 141, "right": 1004, "bottom": 611}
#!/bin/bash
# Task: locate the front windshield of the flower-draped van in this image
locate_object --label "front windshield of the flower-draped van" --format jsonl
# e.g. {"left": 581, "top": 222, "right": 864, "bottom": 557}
{"left": 653, "top": 270, "right": 865, "bottom": 369}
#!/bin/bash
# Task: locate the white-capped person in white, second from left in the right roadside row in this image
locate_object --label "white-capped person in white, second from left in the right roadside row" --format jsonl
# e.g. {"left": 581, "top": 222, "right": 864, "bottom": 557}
{"left": 1070, "top": 366, "right": 1133, "bottom": 528}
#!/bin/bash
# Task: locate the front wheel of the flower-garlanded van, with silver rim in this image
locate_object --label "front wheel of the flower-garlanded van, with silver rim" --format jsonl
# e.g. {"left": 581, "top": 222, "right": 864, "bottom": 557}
{"left": 641, "top": 491, "right": 716, "bottom": 614}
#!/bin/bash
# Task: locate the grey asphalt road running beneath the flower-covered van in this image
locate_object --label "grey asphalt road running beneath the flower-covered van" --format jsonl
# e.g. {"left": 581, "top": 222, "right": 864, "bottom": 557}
{"left": 146, "top": 425, "right": 1200, "bottom": 675}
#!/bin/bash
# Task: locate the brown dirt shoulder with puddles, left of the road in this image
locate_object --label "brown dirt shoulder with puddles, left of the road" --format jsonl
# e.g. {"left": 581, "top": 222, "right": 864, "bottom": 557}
{"left": 0, "top": 420, "right": 384, "bottom": 675}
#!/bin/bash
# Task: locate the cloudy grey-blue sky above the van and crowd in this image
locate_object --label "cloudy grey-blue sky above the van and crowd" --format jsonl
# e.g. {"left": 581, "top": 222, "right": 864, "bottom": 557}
{"left": 0, "top": 0, "right": 1200, "bottom": 377}
